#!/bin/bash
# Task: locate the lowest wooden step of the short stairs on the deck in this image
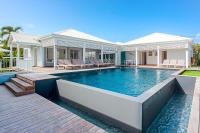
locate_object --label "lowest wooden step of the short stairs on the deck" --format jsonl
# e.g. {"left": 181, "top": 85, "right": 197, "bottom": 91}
{"left": 5, "top": 82, "right": 35, "bottom": 96}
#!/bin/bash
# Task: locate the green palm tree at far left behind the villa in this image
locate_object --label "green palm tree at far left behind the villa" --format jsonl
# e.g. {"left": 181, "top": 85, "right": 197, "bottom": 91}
{"left": 0, "top": 26, "right": 22, "bottom": 48}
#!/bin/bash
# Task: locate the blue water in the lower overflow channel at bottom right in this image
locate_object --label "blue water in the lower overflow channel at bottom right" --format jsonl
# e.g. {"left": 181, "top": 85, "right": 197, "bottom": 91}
{"left": 147, "top": 93, "right": 192, "bottom": 133}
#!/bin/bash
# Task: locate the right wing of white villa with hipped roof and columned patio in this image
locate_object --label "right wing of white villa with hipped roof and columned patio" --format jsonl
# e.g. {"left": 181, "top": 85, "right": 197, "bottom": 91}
{"left": 123, "top": 33, "right": 192, "bottom": 68}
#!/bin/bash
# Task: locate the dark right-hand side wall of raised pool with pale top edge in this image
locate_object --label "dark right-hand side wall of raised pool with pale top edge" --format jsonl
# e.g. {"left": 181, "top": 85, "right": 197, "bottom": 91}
{"left": 139, "top": 78, "right": 177, "bottom": 132}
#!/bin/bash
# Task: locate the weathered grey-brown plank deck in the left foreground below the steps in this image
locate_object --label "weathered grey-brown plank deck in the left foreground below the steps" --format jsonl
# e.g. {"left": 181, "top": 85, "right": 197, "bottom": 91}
{"left": 0, "top": 85, "right": 105, "bottom": 133}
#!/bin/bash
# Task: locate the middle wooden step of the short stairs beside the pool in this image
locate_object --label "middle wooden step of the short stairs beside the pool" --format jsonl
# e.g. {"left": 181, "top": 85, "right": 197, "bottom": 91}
{"left": 11, "top": 78, "right": 34, "bottom": 91}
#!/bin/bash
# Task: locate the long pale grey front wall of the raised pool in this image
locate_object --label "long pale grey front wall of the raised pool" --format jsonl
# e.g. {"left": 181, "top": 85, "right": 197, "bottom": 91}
{"left": 57, "top": 80, "right": 142, "bottom": 130}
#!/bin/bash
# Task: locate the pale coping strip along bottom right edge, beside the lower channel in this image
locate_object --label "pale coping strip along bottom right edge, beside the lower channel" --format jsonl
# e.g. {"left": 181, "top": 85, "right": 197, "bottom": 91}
{"left": 187, "top": 77, "right": 200, "bottom": 133}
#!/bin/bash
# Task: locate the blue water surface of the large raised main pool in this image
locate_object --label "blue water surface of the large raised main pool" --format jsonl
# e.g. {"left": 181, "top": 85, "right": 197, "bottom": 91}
{"left": 63, "top": 68, "right": 175, "bottom": 96}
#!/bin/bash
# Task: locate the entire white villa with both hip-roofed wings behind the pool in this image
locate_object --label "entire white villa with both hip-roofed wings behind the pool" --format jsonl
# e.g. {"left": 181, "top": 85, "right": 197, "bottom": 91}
{"left": 9, "top": 29, "right": 193, "bottom": 69}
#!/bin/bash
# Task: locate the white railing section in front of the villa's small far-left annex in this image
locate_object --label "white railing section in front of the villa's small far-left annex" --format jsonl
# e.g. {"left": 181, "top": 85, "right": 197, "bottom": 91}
{"left": 16, "top": 58, "right": 32, "bottom": 71}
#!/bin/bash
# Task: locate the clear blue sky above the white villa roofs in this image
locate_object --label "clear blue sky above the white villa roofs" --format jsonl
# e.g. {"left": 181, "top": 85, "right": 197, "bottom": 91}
{"left": 0, "top": 0, "right": 200, "bottom": 42}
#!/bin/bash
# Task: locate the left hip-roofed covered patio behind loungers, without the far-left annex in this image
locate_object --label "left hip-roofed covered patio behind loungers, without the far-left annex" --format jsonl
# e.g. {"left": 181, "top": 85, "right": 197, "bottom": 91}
{"left": 41, "top": 31, "right": 120, "bottom": 69}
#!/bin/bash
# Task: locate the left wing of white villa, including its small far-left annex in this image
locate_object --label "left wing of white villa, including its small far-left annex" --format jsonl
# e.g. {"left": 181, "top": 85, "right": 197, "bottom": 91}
{"left": 10, "top": 29, "right": 121, "bottom": 70}
